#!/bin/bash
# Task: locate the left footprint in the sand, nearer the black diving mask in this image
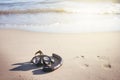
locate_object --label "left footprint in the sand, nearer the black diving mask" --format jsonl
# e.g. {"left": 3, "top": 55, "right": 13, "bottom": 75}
{"left": 75, "top": 56, "right": 89, "bottom": 68}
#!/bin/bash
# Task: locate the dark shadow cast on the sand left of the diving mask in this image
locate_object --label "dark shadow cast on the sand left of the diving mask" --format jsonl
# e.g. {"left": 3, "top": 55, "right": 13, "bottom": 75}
{"left": 10, "top": 62, "right": 49, "bottom": 75}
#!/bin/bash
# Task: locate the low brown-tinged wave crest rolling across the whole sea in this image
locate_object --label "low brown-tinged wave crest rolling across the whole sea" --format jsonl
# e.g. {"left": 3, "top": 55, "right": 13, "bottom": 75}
{"left": 0, "top": 8, "right": 120, "bottom": 15}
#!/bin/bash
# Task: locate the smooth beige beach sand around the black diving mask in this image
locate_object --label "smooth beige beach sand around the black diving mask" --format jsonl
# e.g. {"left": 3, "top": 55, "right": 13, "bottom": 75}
{"left": 0, "top": 30, "right": 120, "bottom": 80}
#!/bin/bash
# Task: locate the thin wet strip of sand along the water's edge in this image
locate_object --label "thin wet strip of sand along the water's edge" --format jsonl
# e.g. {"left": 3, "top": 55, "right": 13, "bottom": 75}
{"left": 0, "top": 28, "right": 120, "bottom": 35}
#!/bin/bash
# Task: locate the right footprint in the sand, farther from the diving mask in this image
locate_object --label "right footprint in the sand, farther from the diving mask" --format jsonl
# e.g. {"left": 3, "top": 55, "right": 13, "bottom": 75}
{"left": 97, "top": 56, "right": 112, "bottom": 69}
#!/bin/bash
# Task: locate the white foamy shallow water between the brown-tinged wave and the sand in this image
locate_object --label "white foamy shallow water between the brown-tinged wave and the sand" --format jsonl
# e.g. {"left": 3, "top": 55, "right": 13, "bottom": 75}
{"left": 0, "top": 13, "right": 120, "bottom": 33}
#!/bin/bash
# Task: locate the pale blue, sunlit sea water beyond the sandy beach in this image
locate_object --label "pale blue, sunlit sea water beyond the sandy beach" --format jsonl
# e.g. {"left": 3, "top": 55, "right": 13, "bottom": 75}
{"left": 0, "top": 0, "right": 120, "bottom": 33}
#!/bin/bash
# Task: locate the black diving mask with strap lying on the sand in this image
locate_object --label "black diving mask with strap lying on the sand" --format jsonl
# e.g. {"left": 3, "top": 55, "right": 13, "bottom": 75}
{"left": 31, "top": 50, "right": 62, "bottom": 72}
